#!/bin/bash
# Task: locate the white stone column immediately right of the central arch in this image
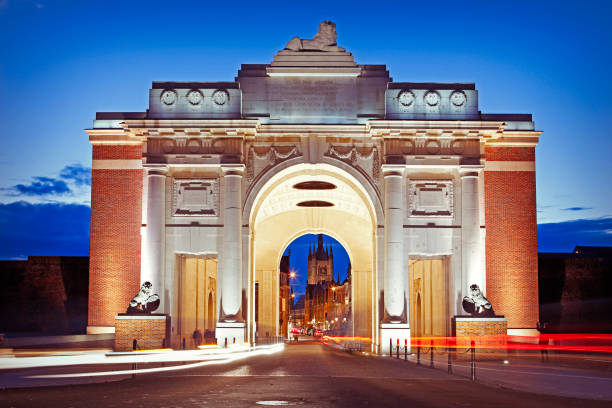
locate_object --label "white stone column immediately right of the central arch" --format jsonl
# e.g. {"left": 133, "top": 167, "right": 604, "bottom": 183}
{"left": 380, "top": 165, "right": 410, "bottom": 353}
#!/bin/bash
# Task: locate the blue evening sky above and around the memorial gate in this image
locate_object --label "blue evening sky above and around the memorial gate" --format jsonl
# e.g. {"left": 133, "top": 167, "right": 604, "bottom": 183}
{"left": 0, "top": 0, "right": 612, "bottom": 258}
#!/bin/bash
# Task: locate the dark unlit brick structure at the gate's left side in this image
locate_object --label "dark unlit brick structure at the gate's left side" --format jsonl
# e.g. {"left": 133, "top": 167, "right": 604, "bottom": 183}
{"left": 0, "top": 256, "right": 89, "bottom": 334}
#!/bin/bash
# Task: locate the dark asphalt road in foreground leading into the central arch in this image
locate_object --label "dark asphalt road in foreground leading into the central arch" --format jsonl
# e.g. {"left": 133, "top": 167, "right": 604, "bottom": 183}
{"left": 0, "top": 343, "right": 612, "bottom": 408}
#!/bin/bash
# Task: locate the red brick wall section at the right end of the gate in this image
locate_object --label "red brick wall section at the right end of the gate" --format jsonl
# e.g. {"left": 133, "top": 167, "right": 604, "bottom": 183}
{"left": 484, "top": 147, "right": 538, "bottom": 329}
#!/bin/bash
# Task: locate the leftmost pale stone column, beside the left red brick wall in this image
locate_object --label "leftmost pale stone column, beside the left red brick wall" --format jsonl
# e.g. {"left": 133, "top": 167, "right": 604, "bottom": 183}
{"left": 141, "top": 168, "right": 167, "bottom": 313}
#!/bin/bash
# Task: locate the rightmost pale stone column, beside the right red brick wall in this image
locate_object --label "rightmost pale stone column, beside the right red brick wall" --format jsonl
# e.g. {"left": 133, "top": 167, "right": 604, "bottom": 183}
{"left": 460, "top": 168, "right": 486, "bottom": 296}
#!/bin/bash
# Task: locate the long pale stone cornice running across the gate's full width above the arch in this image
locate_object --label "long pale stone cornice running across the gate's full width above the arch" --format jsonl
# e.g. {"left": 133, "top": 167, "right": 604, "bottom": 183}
{"left": 86, "top": 119, "right": 542, "bottom": 146}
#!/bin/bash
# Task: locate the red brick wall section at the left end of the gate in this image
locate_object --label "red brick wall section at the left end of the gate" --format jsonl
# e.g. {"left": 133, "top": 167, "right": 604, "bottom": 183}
{"left": 88, "top": 145, "right": 142, "bottom": 326}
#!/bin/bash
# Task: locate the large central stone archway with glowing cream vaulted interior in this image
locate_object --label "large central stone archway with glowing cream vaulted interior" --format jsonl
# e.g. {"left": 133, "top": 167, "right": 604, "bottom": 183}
{"left": 247, "top": 164, "right": 380, "bottom": 339}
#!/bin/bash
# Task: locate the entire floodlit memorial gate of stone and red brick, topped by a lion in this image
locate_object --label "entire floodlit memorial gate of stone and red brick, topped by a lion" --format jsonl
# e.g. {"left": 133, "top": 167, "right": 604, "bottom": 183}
{"left": 87, "top": 21, "right": 541, "bottom": 351}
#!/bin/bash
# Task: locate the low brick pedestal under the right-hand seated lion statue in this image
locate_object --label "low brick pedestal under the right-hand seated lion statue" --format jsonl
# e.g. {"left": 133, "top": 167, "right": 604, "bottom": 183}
{"left": 452, "top": 316, "right": 508, "bottom": 359}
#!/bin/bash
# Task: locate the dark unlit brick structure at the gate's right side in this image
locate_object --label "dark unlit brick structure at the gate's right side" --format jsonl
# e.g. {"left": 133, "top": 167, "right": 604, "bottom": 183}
{"left": 538, "top": 246, "right": 612, "bottom": 332}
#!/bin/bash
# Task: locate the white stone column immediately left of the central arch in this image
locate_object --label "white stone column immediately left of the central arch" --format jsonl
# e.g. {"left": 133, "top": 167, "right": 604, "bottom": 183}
{"left": 215, "top": 165, "right": 245, "bottom": 346}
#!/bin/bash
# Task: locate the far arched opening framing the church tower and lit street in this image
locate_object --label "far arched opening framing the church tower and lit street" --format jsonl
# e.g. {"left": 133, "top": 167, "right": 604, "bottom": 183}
{"left": 279, "top": 234, "right": 353, "bottom": 336}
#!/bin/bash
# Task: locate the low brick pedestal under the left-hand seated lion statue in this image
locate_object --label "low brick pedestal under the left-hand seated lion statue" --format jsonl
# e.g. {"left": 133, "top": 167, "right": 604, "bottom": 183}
{"left": 114, "top": 313, "right": 170, "bottom": 351}
